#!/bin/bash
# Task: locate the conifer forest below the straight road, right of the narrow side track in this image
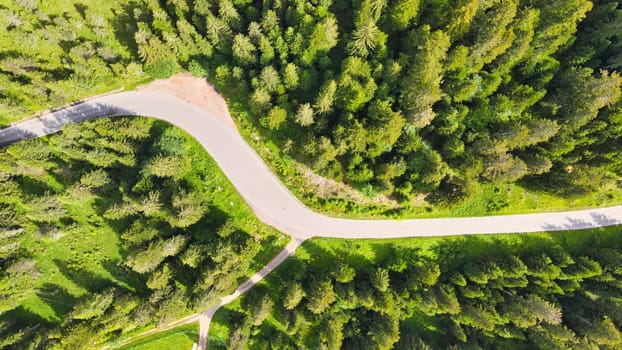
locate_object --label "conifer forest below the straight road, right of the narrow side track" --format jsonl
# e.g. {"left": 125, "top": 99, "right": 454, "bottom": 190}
{"left": 209, "top": 227, "right": 622, "bottom": 350}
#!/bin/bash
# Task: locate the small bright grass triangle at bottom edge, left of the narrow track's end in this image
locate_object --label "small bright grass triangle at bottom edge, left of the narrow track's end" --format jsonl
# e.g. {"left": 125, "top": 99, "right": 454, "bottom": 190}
{"left": 116, "top": 323, "right": 199, "bottom": 350}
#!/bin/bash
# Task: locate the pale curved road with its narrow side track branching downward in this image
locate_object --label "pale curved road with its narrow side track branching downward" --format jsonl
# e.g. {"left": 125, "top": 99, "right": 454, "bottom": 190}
{"left": 0, "top": 91, "right": 622, "bottom": 349}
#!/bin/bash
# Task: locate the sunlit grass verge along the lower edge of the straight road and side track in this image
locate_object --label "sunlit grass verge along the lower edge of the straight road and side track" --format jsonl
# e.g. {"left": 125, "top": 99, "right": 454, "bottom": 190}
{"left": 209, "top": 226, "right": 622, "bottom": 349}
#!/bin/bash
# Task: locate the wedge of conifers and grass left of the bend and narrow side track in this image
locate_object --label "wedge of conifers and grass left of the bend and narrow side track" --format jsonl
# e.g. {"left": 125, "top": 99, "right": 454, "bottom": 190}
{"left": 0, "top": 117, "right": 287, "bottom": 349}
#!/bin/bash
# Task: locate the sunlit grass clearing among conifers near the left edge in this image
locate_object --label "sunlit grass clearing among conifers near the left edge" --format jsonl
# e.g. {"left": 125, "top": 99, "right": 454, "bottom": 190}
{"left": 11, "top": 183, "right": 127, "bottom": 323}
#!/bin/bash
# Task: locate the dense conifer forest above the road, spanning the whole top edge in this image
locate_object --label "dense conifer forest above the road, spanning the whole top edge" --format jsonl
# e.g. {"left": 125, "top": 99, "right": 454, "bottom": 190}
{"left": 0, "top": 0, "right": 622, "bottom": 211}
